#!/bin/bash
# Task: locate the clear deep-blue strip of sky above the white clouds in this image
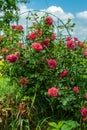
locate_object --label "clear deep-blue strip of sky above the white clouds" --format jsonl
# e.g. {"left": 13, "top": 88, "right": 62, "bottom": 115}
{"left": 27, "top": 0, "right": 87, "bottom": 13}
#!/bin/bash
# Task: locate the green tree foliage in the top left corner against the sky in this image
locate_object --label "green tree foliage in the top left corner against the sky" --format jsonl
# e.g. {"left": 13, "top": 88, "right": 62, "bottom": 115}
{"left": 0, "top": 0, "right": 28, "bottom": 26}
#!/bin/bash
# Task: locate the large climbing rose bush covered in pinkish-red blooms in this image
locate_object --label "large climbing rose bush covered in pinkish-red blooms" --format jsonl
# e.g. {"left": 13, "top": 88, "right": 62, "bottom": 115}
{"left": 0, "top": 16, "right": 87, "bottom": 129}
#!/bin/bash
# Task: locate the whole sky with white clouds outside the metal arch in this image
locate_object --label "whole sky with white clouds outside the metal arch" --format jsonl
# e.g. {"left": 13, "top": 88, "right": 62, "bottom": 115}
{"left": 19, "top": 0, "right": 87, "bottom": 41}
